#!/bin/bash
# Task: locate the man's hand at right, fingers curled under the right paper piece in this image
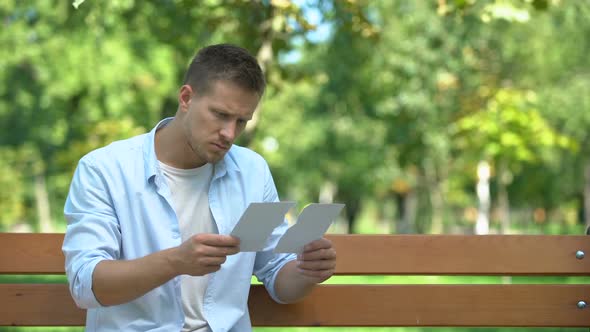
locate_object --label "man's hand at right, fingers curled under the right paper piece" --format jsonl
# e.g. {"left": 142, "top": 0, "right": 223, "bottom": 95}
{"left": 297, "top": 238, "right": 336, "bottom": 284}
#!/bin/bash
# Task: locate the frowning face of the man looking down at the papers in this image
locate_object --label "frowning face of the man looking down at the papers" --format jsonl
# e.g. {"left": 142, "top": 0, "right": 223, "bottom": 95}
{"left": 179, "top": 80, "right": 259, "bottom": 167}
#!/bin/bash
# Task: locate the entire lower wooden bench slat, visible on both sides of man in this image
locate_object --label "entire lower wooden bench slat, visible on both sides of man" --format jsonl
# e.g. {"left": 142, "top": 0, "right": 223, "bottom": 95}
{"left": 0, "top": 284, "right": 590, "bottom": 327}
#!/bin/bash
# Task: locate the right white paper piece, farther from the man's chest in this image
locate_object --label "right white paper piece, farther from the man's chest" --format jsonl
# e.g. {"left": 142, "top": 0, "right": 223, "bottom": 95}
{"left": 274, "top": 204, "right": 344, "bottom": 254}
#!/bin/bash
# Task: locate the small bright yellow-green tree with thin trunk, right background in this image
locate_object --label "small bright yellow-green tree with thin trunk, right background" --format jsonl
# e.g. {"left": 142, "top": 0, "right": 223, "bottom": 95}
{"left": 456, "top": 89, "right": 575, "bottom": 233}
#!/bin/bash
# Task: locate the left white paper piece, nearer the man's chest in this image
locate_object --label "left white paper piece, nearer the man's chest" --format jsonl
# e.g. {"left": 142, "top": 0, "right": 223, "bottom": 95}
{"left": 231, "top": 202, "right": 295, "bottom": 251}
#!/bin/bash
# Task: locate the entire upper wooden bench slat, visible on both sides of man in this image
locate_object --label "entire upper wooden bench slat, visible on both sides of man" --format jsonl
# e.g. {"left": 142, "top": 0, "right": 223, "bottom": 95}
{"left": 0, "top": 233, "right": 590, "bottom": 275}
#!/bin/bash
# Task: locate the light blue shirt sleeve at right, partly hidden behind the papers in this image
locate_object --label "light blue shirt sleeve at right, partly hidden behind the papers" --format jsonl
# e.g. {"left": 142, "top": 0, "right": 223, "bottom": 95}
{"left": 254, "top": 163, "right": 297, "bottom": 303}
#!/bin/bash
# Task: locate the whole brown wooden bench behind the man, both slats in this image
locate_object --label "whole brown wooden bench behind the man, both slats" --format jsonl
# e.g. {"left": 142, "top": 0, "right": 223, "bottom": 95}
{"left": 0, "top": 233, "right": 590, "bottom": 327}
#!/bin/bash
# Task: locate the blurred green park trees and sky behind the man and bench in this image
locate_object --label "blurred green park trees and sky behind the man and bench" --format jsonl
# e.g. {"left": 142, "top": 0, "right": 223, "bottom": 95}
{"left": 0, "top": 0, "right": 590, "bottom": 331}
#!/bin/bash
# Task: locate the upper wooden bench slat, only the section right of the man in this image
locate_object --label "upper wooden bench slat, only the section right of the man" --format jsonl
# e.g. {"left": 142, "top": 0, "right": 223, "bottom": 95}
{"left": 330, "top": 235, "right": 590, "bottom": 275}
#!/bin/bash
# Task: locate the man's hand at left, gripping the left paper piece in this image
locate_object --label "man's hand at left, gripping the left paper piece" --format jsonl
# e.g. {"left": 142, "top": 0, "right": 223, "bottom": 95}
{"left": 171, "top": 234, "right": 240, "bottom": 276}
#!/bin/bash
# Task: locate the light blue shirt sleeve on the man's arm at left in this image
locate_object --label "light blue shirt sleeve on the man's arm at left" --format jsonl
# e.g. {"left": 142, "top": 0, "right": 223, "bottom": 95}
{"left": 62, "top": 157, "right": 121, "bottom": 309}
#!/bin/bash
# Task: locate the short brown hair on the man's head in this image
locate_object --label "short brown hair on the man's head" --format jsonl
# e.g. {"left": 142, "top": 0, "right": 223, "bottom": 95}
{"left": 183, "top": 44, "right": 266, "bottom": 96}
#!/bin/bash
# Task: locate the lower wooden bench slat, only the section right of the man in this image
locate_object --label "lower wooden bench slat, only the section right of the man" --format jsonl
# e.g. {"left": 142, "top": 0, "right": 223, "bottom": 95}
{"left": 250, "top": 285, "right": 590, "bottom": 327}
